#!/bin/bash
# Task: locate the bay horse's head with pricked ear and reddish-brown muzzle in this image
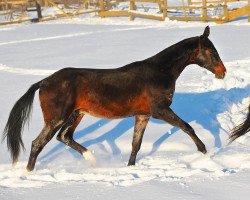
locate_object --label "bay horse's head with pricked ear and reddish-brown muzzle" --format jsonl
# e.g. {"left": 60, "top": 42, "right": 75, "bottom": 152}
{"left": 195, "top": 26, "right": 226, "bottom": 79}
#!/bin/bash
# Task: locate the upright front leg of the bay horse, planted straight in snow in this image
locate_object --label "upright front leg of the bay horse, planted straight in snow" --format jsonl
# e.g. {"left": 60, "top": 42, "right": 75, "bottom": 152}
{"left": 128, "top": 115, "right": 149, "bottom": 165}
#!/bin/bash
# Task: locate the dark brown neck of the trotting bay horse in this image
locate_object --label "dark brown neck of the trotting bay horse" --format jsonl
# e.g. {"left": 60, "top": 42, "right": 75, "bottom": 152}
{"left": 151, "top": 38, "right": 198, "bottom": 79}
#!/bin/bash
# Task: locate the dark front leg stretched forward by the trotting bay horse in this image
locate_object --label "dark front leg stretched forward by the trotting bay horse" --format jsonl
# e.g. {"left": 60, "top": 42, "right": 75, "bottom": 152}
{"left": 152, "top": 103, "right": 207, "bottom": 154}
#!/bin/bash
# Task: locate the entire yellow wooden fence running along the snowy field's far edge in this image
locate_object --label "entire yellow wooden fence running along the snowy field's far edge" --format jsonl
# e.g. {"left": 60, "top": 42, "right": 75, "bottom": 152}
{"left": 0, "top": 0, "right": 250, "bottom": 25}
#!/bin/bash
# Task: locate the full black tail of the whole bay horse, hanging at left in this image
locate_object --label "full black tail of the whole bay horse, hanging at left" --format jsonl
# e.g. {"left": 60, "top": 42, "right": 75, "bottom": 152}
{"left": 2, "top": 81, "right": 41, "bottom": 164}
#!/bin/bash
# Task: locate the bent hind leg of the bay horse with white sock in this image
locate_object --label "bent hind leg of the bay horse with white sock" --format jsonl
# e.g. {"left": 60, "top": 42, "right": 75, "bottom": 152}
{"left": 57, "top": 110, "right": 96, "bottom": 167}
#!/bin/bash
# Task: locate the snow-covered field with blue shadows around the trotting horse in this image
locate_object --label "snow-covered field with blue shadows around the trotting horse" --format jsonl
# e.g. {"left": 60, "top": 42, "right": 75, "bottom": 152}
{"left": 0, "top": 15, "right": 250, "bottom": 200}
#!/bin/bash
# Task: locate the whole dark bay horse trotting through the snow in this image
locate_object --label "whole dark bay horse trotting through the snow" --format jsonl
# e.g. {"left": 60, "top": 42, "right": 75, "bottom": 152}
{"left": 3, "top": 26, "right": 226, "bottom": 171}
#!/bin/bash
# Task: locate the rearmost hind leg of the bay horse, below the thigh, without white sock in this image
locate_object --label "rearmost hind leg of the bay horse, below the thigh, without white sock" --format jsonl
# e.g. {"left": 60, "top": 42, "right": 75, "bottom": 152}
{"left": 26, "top": 121, "right": 62, "bottom": 171}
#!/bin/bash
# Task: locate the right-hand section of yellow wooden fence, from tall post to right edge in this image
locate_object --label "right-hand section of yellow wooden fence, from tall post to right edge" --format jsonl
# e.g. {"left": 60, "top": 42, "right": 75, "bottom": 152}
{"left": 99, "top": 0, "right": 250, "bottom": 23}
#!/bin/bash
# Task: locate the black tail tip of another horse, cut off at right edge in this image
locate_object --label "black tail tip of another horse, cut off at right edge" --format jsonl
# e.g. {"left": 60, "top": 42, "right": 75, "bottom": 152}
{"left": 229, "top": 105, "right": 250, "bottom": 143}
